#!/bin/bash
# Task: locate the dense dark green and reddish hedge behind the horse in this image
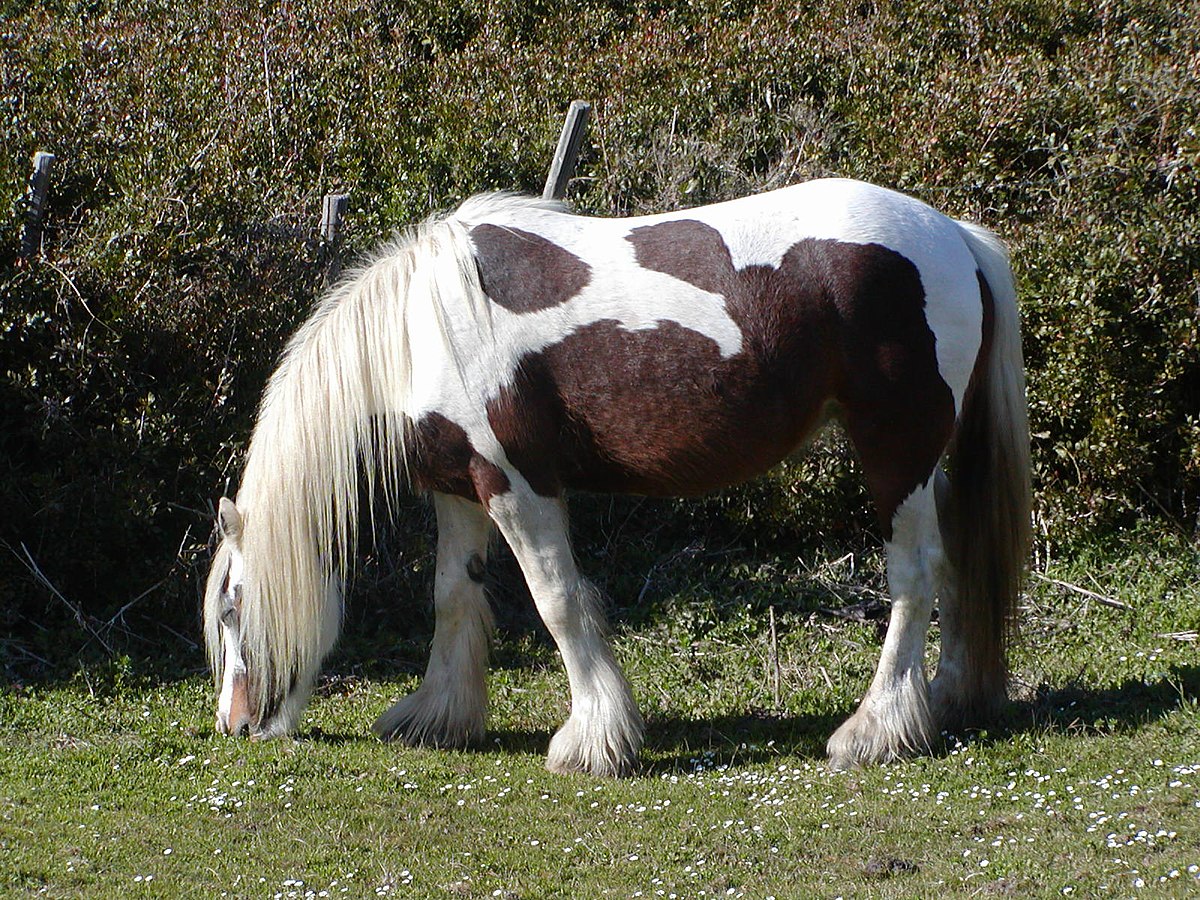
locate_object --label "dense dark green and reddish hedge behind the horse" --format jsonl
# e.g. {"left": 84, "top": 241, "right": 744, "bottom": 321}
{"left": 0, "top": 0, "right": 1200, "bottom": 653}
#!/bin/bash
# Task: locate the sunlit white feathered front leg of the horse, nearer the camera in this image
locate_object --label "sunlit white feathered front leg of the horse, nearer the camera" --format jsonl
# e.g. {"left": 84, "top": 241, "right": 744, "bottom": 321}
{"left": 488, "top": 484, "right": 643, "bottom": 776}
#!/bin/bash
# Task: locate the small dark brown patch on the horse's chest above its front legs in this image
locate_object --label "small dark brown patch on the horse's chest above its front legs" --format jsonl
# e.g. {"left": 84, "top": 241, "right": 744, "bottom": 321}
{"left": 408, "top": 413, "right": 509, "bottom": 505}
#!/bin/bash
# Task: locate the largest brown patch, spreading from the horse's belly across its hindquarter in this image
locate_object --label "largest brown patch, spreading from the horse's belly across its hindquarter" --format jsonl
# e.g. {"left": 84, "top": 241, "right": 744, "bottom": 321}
{"left": 487, "top": 220, "right": 954, "bottom": 539}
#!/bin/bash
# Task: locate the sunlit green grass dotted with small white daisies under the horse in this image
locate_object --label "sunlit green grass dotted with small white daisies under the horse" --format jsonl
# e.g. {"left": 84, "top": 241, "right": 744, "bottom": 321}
{"left": 0, "top": 533, "right": 1200, "bottom": 898}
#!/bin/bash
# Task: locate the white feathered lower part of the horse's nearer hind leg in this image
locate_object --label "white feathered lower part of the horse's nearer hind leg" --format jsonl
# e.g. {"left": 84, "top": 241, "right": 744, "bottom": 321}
{"left": 826, "top": 479, "right": 944, "bottom": 768}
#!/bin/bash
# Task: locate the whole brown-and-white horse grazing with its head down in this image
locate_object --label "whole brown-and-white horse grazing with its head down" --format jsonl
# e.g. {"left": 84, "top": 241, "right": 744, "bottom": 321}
{"left": 204, "top": 180, "right": 1030, "bottom": 775}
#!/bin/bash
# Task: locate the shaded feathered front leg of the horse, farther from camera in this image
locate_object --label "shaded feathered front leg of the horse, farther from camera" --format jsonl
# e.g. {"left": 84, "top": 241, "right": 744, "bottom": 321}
{"left": 372, "top": 493, "right": 492, "bottom": 746}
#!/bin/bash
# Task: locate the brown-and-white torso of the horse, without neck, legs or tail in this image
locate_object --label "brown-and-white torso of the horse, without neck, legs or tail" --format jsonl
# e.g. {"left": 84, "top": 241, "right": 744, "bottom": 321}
{"left": 439, "top": 180, "right": 983, "bottom": 508}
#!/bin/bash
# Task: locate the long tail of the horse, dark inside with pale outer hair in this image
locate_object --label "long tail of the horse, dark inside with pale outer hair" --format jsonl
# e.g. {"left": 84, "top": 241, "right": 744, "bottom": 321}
{"left": 940, "top": 223, "right": 1032, "bottom": 719}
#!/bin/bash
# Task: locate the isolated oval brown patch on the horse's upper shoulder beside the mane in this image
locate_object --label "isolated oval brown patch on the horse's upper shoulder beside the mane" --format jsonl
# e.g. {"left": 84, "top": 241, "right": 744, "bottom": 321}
{"left": 470, "top": 224, "right": 592, "bottom": 312}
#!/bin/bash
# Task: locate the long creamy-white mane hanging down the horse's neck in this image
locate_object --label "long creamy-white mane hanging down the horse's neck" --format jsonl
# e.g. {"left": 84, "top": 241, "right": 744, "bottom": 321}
{"left": 223, "top": 194, "right": 559, "bottom": 715}
